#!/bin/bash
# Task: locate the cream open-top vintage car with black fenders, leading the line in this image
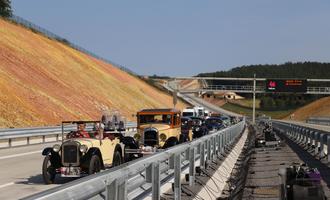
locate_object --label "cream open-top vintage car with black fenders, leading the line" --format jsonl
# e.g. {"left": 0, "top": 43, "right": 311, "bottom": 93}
{"left": 42, "top": 121, "right": 139, "bottom": 184}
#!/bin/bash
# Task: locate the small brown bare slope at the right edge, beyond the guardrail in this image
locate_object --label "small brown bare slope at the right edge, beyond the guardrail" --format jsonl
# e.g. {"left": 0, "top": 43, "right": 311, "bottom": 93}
{"left": 287, "top": 97, "right": 330, "bottom": 121}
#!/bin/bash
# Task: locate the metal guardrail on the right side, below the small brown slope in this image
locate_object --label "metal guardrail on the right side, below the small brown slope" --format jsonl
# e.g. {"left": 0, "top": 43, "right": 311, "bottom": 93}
{"left": 272, "top": 121, "right": 330, "bottom": 163}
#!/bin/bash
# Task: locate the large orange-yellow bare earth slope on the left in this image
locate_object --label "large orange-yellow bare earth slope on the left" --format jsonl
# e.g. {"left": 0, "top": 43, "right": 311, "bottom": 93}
{"left": 0, "top": 19, "right": 185, "bottom": 127}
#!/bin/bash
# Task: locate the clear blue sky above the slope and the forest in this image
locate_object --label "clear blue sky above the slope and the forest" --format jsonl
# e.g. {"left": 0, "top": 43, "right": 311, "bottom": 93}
{"left": 12, "top": 0, "right": 330, "bottom": 76}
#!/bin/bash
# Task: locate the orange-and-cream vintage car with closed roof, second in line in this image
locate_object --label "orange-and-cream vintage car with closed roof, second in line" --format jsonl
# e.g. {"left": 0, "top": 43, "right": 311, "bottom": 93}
{"left": 134, "top": 109, "right": 187, "bottom": 148}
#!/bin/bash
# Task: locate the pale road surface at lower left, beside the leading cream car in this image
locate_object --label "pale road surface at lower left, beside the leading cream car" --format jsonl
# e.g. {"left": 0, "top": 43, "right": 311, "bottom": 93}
{"left": 0, "top": 143, "right": 63, "bottom": 199}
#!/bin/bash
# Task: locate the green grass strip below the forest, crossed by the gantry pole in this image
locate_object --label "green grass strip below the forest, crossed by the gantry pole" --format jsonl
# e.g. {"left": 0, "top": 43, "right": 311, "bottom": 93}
{"left": 221, "top": 103, "right": 295, "bottom": 119}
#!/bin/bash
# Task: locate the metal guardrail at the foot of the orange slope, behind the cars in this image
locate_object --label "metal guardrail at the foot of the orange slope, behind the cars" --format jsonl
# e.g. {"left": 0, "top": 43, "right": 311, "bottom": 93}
{"left": 0, "top": 122, "right": 136, "bottom": 149}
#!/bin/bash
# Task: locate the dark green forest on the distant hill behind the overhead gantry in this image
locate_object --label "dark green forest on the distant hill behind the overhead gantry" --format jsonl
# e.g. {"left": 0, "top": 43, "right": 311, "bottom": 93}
{"left": 197, "top": 62, "right": 330, "bottom": 110}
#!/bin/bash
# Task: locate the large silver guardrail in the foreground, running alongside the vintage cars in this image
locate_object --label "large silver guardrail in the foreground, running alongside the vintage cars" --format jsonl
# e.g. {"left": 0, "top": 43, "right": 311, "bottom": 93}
{"left": 26, "top": 120, "right": 245, "bottom": 200}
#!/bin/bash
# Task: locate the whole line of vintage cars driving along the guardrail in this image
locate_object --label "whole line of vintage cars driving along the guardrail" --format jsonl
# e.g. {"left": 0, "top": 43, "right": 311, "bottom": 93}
{"left": 42, "top": 107, "right": 235, "bottom": 184}
